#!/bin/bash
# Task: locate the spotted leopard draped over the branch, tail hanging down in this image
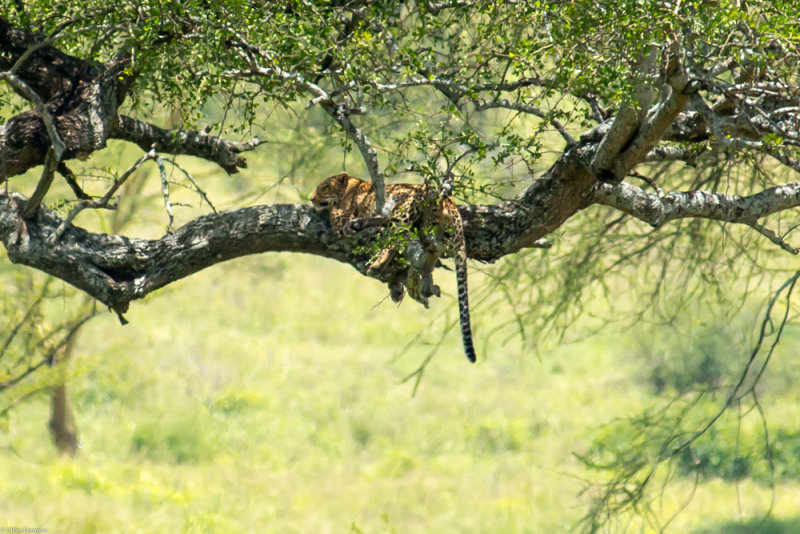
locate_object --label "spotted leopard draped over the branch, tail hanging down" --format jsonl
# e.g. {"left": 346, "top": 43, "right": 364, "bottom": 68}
{"left": 310, "top": 172, "right": 477, "bottom": 363}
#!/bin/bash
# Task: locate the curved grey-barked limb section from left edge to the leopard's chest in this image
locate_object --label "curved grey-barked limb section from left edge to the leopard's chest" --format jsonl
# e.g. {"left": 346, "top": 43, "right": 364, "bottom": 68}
{"left": 0, "top": 193, "right": 334, "bottom": 312}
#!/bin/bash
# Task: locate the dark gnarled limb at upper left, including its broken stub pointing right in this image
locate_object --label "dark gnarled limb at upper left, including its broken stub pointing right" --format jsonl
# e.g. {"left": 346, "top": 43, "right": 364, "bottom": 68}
{"left": 0, "top": 17, "right": 260, "bottom": 183}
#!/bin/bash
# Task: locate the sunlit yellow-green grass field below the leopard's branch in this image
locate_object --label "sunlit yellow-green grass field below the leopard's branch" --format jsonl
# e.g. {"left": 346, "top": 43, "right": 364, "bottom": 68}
{"left": 0, "top": 248, "right": 800, "bottom": 533}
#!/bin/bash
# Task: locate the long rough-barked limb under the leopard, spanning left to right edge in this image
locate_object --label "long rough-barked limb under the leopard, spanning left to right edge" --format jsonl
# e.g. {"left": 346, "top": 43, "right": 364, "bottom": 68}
{"left": 9, "top": 151, "right": 800, "bottom": 312}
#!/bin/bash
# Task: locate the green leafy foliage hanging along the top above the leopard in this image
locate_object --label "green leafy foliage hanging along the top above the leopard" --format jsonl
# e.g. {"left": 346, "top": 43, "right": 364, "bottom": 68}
{"left": 0, "top": 0, "right": 800, "bottom": 195}
